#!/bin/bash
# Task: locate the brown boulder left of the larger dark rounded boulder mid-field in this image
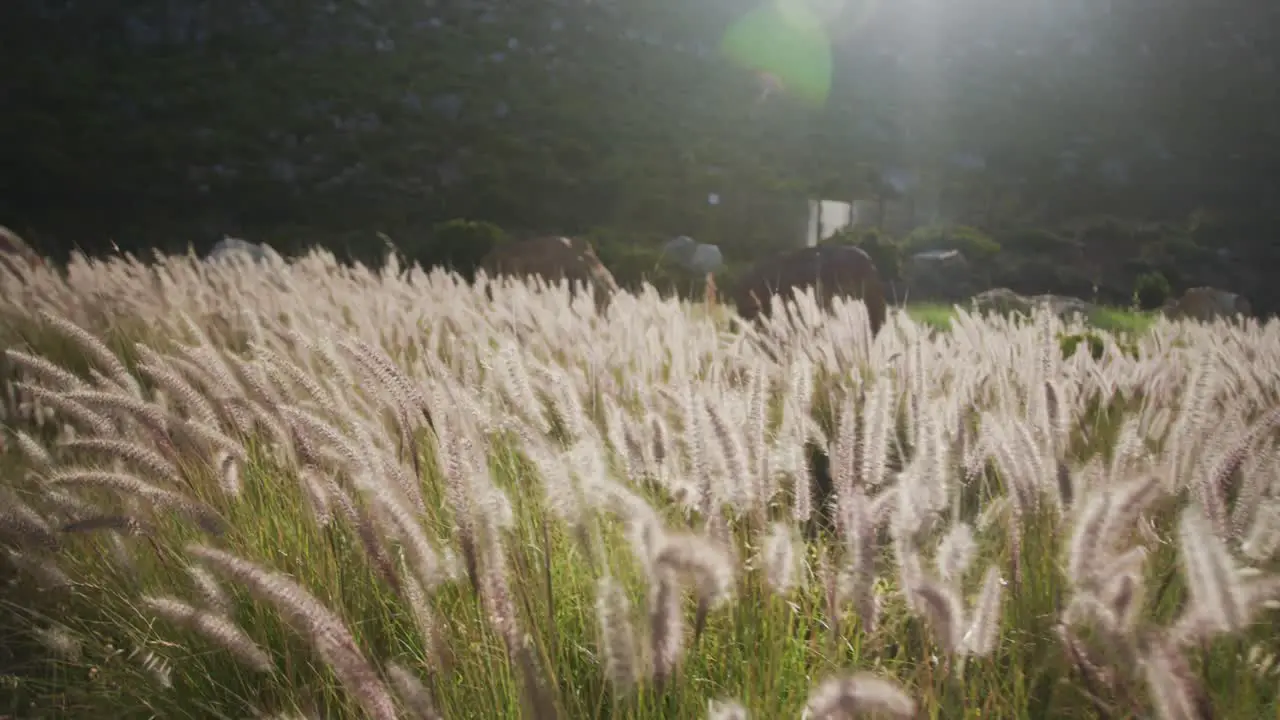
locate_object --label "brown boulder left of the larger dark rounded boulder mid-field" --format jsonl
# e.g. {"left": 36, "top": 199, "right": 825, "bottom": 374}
{"left": 480, "top": 236, "right": 618, "bottom": 311}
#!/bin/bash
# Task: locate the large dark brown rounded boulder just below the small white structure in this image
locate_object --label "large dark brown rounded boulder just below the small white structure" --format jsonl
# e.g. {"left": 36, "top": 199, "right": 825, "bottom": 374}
{"left": 733, "top": 245, "right": 887, "bottom": 333}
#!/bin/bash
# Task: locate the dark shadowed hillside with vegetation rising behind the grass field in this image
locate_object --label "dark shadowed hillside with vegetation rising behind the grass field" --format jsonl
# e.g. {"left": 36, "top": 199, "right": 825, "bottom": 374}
{"left": 0, "top": 0, "right": 1280, "bottom": 311}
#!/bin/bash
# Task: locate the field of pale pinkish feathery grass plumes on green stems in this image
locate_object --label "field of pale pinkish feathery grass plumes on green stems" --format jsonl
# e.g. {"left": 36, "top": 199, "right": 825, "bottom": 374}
{"left": 0, "top": 248, "right": 1280, "bottom": 720}
